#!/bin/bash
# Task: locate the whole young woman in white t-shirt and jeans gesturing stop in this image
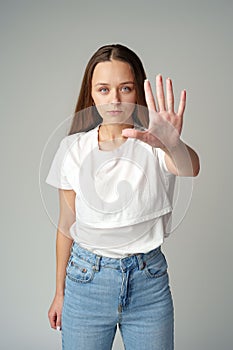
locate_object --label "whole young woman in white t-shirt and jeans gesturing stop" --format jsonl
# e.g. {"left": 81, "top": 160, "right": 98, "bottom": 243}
{"left": 46, "top": 45, "right": 199, "bottom": 350}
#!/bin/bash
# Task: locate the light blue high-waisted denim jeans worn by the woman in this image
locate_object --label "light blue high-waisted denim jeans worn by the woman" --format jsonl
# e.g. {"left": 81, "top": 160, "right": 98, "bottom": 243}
{"left": 62, "top": 243, "right": 174, "bottom": 350}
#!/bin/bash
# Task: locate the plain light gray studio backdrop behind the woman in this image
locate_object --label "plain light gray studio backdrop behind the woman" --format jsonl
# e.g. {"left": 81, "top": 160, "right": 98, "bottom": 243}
{"left": 0, "top": 0, "right": 233, "bottom": 350}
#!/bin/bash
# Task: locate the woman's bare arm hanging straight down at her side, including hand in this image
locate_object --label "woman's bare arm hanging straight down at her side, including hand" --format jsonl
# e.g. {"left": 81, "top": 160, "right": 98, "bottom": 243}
{"left": 48, "top": 189, "right": 75, "bottom": 329}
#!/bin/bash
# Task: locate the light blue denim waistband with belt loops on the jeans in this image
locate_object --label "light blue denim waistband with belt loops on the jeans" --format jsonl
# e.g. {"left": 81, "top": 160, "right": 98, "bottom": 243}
{"left": 71, "top": 242, "right": 161, "bottom": 271}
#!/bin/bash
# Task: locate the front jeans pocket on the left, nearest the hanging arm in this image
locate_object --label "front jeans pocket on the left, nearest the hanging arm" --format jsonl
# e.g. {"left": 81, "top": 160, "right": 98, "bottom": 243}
{"left": 66, "top": 256, "right": 95, "bottom": 283}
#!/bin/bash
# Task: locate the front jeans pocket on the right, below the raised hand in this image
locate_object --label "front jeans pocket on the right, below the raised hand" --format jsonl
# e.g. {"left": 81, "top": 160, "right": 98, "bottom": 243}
{"left": 143, "top": 252, "right": 168, "bottom": 278}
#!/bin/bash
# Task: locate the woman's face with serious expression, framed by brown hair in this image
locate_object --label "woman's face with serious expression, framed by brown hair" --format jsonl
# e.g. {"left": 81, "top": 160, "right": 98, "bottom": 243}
{"left": 91, "top": 60, "right": 137, "bottom": 123}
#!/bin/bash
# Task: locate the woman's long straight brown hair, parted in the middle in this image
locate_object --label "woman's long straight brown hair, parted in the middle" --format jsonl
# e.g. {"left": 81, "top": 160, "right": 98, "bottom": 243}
{"left": 69, "top": 44, "right": 149, "bottom": 135}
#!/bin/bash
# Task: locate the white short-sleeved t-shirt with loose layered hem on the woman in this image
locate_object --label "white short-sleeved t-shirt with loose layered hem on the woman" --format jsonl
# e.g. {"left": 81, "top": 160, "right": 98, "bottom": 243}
{"left": 46, "top": 126, "right": 176, "bottom": 258}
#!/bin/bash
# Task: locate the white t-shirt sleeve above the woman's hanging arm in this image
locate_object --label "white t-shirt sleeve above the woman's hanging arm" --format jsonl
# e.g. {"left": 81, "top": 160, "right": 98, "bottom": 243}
{"left": 45, "top": 136, "right": 73, "bottom": 190}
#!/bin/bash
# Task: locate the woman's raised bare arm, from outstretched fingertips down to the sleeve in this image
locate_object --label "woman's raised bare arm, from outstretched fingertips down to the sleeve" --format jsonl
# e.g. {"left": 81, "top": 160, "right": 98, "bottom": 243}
{"left": 122, "top": 75, "right": 200, "bottom": 176}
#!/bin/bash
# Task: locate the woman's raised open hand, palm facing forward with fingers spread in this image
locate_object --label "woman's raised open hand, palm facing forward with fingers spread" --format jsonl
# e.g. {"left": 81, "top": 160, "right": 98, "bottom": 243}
{"left": 122, "top": 75, "right": 186, "bottom": 150}
